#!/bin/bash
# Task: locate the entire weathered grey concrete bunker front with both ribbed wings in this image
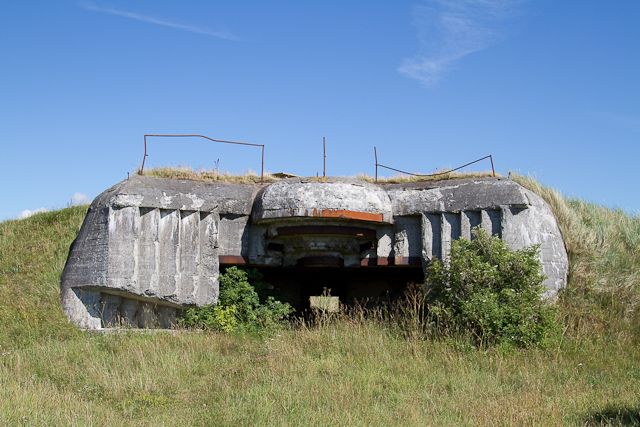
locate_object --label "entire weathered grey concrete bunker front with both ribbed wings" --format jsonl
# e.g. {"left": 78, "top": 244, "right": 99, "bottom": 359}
{"left": 61, "top": 176, "right": 568, "bottom": 329}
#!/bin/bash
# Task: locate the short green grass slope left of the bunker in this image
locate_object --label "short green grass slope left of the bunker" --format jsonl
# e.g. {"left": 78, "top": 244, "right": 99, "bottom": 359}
{"left": 0, "top": 207, "right": 87, "bottom": 352}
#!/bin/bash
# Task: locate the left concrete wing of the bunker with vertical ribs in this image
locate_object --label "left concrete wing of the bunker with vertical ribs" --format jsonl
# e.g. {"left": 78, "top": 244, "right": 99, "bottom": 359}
{"left": 61, "top": 176, "right": 258, "bottom": 329}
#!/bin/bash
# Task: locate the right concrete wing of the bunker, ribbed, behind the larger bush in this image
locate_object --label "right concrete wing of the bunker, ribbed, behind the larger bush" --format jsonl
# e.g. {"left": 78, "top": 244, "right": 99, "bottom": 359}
{"left": 386, "top": 178, "right": 569, "bottom": 295}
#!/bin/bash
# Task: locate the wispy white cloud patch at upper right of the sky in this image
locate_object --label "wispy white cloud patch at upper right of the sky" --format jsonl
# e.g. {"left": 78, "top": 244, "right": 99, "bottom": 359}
{"left": 398, "top": 0, "right": 520, "bottom": 87}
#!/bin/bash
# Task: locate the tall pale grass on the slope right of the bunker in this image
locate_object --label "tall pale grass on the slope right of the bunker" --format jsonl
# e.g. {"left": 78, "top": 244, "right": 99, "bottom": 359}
{"left": 513, "top": 175, "right": 640, "bottom": 335}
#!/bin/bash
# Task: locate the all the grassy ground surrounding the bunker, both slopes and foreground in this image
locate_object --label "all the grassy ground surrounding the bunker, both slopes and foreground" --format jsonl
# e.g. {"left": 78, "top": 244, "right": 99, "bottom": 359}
{"left": 0, "top": 177, "right": 640, "bottom": 426}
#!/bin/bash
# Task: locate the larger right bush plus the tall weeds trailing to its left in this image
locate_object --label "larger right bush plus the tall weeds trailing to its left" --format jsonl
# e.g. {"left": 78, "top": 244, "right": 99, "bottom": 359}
{"left": 284, "top": 228, "right": 562, "bottom": 349}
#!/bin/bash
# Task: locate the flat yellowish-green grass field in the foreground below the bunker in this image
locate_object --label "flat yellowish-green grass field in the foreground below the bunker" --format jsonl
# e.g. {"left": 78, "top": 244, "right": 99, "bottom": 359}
{"left": 0, "top": 322, "right": 640, "bottom": 425}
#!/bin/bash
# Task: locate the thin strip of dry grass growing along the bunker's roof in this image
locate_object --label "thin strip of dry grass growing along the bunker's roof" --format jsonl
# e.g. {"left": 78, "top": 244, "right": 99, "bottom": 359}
{"left": 143, "top": 167, "right": 499, "bottom": 184}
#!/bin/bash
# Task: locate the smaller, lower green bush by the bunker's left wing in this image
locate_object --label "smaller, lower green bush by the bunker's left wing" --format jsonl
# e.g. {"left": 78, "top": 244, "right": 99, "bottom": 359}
{"left": 181, "top": 267, "right": 293, "bottom": 332}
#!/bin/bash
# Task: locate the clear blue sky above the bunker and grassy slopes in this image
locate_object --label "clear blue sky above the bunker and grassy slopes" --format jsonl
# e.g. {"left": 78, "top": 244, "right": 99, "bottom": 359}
{"left": 0, "top": 0, "right": 640, "bottom": 219}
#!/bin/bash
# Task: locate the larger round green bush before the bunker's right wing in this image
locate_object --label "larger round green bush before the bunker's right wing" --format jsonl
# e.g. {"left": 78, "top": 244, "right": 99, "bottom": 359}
{"left": 426, "top": 228, "right": 559, "bottom": 347}
